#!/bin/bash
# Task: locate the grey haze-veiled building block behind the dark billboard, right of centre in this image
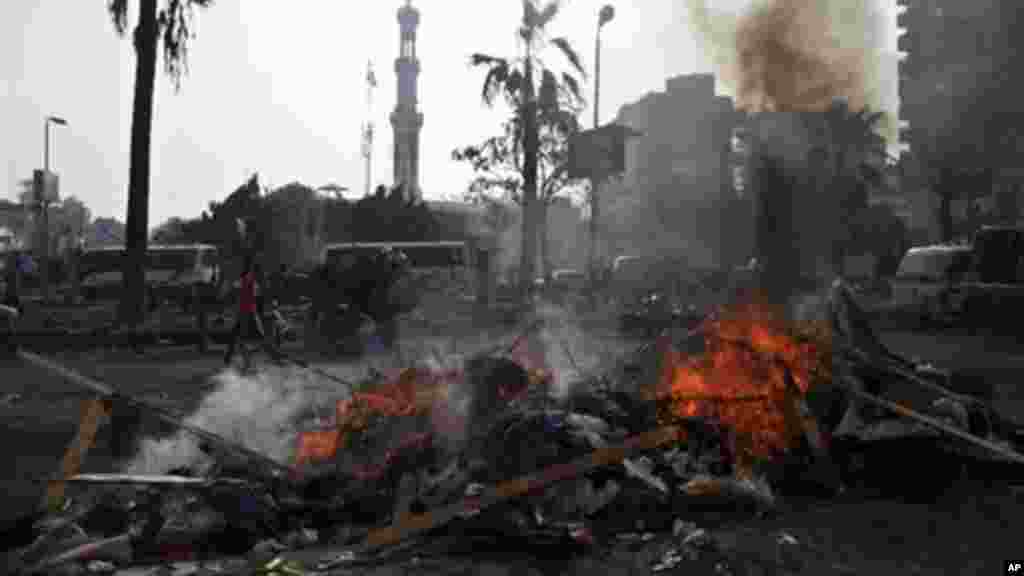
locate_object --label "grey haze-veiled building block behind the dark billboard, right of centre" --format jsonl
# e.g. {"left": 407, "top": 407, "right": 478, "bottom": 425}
{"left": 602, "top": 74, "right": 738, "bottom": 268}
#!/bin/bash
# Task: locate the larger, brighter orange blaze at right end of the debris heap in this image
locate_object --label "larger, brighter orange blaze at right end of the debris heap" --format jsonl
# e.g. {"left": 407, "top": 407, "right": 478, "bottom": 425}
{"left": 658, "top": 295, "right": 828, "bottom": 457}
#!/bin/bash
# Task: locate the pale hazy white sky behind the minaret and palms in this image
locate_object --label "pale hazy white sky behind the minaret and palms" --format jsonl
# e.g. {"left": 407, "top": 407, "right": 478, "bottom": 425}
{"left": 0, "top": 0, "right": 896, "bottom": 225}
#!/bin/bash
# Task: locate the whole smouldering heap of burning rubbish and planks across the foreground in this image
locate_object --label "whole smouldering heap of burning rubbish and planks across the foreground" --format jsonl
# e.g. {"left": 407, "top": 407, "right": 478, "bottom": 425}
{"left": 6, "top": 286, "right": 1024, "bottom": 574}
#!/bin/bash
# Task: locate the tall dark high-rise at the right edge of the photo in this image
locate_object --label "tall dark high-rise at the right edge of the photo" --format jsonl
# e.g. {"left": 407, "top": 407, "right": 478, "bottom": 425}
{"left": 898, "top": 0, "right": 1024, "bottom": 228}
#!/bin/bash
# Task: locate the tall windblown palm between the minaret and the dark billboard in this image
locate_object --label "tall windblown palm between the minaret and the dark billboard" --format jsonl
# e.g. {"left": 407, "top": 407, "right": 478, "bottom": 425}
{"left": 471, "top": 0, "right": 586, "bottom": 302}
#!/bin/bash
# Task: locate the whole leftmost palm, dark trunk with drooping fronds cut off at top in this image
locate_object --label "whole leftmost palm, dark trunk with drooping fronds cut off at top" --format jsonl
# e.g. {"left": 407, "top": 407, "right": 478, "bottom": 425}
{"left": 106, "top": 0, "right": 213, "bottom": 323}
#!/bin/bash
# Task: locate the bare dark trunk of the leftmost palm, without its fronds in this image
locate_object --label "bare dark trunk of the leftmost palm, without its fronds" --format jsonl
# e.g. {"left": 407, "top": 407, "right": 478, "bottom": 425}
{"left": 122, "top": 0, "right": 159, "bottom": 324}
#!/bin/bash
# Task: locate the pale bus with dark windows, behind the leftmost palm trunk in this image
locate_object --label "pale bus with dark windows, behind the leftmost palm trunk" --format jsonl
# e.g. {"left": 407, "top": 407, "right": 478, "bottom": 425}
{"left": 79, "top": 244, "right": 220, "bottom": 307}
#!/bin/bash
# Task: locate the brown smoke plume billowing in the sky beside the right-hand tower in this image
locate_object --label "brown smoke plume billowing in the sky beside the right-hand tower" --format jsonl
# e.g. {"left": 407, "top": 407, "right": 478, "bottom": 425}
{"left": 688, "top": 0, "right": 897, "bottom": 141}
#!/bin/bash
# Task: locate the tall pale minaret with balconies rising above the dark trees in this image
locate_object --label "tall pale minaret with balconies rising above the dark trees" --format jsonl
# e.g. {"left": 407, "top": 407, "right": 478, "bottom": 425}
{"left": 391, "top": 0, "right": 423, "bottom": 198}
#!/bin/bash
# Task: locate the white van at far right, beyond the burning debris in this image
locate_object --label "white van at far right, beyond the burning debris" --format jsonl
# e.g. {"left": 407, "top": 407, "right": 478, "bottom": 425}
{"left": 892, "top": 245, "right": 974, "bottom": 321}
